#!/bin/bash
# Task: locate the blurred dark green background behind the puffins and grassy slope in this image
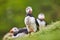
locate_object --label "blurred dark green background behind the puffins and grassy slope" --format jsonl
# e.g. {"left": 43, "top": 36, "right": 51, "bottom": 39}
{"left": 0, "top": 0, "right": 60, "bottom": 38}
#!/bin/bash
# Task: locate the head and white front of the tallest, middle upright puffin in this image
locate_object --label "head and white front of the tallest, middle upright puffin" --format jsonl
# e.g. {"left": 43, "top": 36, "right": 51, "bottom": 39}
{"left": 24, "top": 7, "right": 37, "bottom": 32}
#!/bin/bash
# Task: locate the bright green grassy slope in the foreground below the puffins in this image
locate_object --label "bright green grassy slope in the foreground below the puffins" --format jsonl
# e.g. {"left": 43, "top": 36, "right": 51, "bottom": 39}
{"left": 8, "top": 21, "right": 60, "bottom": 40}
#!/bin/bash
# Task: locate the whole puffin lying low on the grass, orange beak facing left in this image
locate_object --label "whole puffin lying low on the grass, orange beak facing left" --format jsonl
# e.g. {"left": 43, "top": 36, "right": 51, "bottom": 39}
{"left": 10, "top": 27, "right": 28, "bottom": 37}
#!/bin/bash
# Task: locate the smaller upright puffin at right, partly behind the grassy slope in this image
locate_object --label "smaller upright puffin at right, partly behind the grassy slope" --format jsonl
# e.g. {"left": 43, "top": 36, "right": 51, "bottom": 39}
{"left": 36, "top": 13, "right": 46, "bottom": 29}
